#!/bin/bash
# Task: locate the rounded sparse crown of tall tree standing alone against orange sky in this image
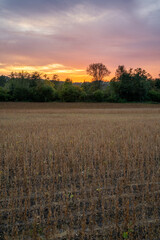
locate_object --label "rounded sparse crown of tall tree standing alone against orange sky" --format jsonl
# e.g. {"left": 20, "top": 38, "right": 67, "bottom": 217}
{"left": 87, "top": 63, "right": 110, "bottom": 81}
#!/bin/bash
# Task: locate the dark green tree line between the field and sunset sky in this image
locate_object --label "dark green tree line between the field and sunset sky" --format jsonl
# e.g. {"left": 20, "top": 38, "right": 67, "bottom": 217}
{"left": 0, "top": 63, "right": 160, "bottom": 102}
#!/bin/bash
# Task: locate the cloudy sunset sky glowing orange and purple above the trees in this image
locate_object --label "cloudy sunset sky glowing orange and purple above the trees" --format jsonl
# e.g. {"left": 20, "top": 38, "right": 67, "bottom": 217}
{"left": 0, "top": 0, "right": 160, "bottom": 81}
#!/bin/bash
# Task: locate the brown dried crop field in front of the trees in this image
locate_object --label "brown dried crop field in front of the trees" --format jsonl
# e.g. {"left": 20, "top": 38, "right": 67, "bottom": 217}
{"left": 0, "top": 103, "right": 160, "bottom": 240}
